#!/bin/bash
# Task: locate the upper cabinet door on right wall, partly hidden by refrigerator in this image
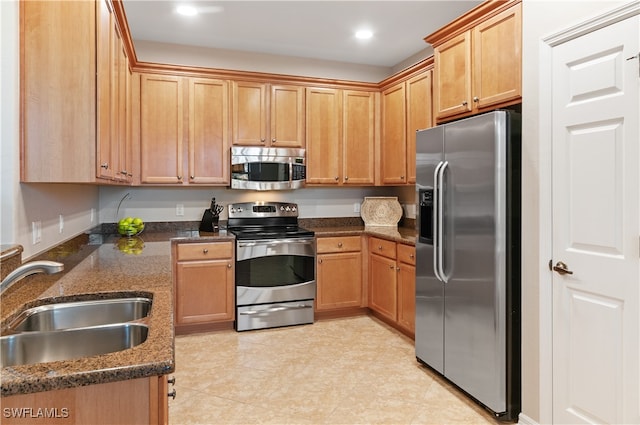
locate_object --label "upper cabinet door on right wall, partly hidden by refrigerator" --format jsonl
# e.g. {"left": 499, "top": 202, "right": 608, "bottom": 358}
{"left": 407, "top": 70, "right": 433, "bottom": 183}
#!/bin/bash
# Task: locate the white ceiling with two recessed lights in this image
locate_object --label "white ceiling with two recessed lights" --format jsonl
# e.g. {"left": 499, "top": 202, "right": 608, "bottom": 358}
{"left": 123, "top": 0, "right": 482, "bottom": 67}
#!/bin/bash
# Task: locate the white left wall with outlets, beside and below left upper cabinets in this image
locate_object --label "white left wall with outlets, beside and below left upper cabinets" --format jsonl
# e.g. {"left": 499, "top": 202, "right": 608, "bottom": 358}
{"left": 0, "top": 0, "right": 98, "bottom": 259}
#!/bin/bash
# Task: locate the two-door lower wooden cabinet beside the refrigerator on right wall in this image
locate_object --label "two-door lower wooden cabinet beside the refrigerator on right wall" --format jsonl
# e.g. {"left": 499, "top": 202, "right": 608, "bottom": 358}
{"left": 368, "top": 236, "right": 416, "bottom": 336}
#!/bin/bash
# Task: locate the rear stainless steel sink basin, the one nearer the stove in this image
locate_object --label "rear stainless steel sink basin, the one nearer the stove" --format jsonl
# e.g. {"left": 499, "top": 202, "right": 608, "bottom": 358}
{"left": 8, "top": 297, "right": 151, "bottom": 332}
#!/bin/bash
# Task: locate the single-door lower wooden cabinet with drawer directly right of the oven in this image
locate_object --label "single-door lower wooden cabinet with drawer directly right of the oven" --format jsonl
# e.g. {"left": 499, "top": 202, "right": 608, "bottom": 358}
{"left": 316, "top": 236, "right": 363, "bottom": 311}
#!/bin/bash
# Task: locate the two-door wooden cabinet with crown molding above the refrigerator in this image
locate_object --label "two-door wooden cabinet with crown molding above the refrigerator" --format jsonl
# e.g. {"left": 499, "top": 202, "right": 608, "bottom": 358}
{"left": 425, "top": 1, "right": 522, "bottom": 121}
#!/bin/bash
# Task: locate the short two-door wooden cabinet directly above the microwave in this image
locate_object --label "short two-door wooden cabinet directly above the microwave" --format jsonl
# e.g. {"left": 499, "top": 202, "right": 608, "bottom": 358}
{"left": 232, "top": 81, "right": 305, "bottom": 148}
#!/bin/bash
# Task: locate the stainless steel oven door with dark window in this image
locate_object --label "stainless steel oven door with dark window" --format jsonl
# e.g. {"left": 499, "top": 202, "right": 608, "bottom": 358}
{"left": 236, "top": 238, "right": 316, "bottom": 307}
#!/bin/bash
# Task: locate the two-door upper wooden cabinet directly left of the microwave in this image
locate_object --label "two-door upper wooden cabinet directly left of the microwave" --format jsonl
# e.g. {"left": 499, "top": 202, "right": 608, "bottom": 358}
{"left": 139, "top": 74, "right": 229, "bottom": 185}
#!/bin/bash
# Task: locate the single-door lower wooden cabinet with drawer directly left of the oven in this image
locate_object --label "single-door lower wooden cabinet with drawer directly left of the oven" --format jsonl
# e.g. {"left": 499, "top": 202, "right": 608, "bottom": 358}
{"left": 172, "top": 241, "right": 235, "bottom": 333}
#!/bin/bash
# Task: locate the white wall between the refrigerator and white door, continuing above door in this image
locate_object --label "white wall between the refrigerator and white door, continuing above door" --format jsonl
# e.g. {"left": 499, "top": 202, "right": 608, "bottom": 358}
{"left": 521, "top": 0, "right": 628, "bottom": 424}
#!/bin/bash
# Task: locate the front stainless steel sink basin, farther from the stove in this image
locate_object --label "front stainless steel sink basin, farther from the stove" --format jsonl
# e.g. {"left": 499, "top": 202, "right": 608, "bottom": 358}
{"left": 0, "top": 323, "right": 149, "bottom": 367}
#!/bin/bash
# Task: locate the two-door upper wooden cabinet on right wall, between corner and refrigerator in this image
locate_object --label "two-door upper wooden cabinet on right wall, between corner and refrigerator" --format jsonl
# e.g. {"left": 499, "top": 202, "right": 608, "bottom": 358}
{"left": 380, "top": 69, "right": 433, "bottom": 185}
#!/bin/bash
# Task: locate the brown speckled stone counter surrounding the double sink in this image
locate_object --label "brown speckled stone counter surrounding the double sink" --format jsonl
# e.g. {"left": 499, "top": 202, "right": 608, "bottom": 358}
{"left": 0, "top": 231, "right": 233, "bottom": 396}
